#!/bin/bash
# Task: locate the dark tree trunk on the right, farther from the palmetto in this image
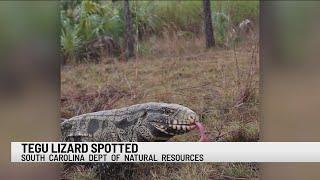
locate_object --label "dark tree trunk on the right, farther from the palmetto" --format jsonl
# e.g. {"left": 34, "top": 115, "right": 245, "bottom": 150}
{"left": 203, "top": 0, "right": 215, "bottom": 48}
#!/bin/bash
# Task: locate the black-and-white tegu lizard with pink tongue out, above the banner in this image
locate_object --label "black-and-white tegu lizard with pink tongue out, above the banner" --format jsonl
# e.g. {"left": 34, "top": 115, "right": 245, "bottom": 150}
{"left": 61, "top": 102, "right": 206, "bottom": 142}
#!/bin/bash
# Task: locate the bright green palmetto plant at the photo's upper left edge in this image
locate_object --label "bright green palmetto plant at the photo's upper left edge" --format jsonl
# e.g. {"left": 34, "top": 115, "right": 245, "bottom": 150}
{"left": 60, "top": 1, "right": 112, "bottom": 60}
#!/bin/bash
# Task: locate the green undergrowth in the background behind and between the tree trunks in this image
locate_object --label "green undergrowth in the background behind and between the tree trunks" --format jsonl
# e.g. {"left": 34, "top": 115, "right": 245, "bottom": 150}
{"left": 60, "top": 0, "right": 259, "bottom": 62}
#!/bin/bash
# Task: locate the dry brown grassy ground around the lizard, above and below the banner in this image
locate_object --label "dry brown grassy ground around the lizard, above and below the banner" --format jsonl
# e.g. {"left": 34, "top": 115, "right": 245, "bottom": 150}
{"left": 61, "top": 35, "right": 259, "bottom": 179}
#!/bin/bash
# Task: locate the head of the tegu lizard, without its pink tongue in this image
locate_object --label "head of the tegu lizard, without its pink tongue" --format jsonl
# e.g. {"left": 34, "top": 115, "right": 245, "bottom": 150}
{"left": 140, "top": 103, "right": 199, "bottom": 141}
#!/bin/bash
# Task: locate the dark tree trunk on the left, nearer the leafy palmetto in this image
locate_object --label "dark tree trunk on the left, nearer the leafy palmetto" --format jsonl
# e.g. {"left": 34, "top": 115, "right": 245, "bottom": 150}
{"left": 123, "top": 0, "right": 134, "bottom": 59}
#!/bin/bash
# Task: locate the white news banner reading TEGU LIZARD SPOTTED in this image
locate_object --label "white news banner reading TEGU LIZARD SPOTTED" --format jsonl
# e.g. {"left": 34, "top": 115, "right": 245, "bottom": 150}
{"left": 11, "top": 142, "right": 320, "bottom": 162}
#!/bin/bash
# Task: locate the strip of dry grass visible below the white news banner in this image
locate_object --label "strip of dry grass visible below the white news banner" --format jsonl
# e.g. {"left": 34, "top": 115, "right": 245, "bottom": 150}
{"left": 62, "top": 163, "right": 259, "bottom": 180}
